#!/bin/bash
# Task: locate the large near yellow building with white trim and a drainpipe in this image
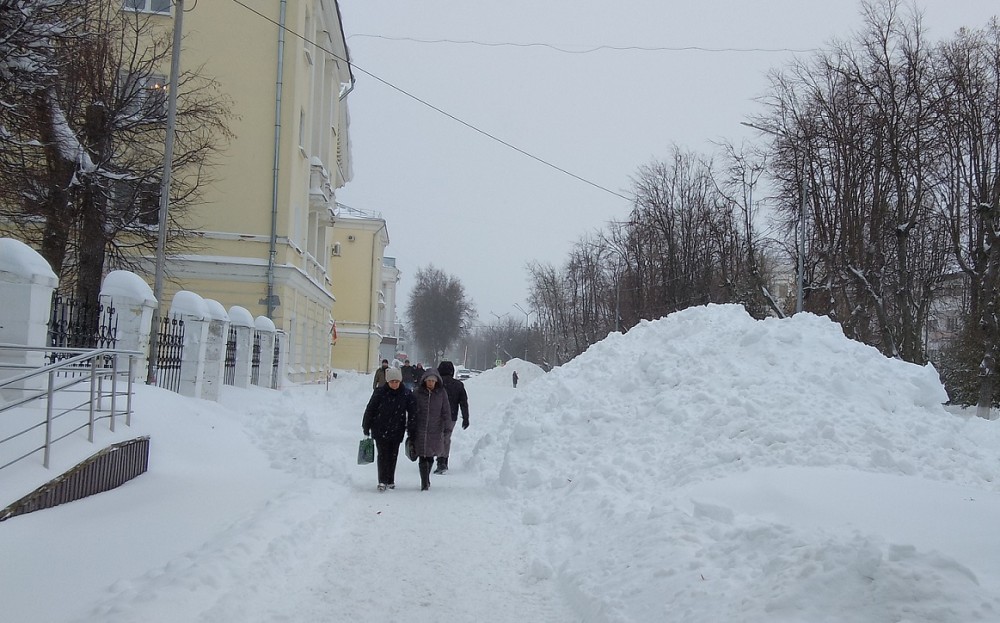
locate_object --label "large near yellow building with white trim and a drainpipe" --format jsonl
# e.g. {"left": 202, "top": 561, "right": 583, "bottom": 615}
{"left": 139, "top": 0, "right": 354, "bottom": 381}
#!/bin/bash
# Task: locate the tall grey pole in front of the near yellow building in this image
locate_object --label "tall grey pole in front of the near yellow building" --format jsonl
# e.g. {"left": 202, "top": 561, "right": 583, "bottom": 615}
{"left": 146, "top": 0, "right": 184, "bottom": 385}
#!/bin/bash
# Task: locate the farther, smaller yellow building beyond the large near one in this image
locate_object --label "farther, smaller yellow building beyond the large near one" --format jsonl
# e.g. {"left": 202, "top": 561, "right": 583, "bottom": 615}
{"left": 330, "top": 206, "right": 395, "bottom": 372}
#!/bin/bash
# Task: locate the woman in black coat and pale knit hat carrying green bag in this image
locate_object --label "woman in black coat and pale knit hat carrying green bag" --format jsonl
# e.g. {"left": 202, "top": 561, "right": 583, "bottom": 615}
{"left": 361, "top": 368, "right": 416, "bottom": 492}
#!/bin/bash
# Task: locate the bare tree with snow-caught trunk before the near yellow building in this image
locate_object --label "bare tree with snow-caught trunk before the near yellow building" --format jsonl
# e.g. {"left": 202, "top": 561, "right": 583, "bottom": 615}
{"left": 0, "top": 0, "right": 231, "bottom": 302}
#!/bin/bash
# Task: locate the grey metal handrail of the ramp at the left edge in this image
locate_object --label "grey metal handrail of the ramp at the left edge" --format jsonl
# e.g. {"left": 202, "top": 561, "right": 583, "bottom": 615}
{"left": 0, "top": 344, "right": 142, "bottom": 470}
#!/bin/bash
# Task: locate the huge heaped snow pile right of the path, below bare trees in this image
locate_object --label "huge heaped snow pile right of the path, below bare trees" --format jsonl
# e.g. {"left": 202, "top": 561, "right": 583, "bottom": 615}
{"left": 470, "top": 306, "right": 1000, "bottom": 622}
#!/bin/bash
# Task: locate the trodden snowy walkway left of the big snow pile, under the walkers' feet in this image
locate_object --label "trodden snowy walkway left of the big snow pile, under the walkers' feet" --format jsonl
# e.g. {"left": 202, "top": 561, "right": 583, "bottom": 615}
{"left": 15, "top": 383, "right": 578, "bottom": 623}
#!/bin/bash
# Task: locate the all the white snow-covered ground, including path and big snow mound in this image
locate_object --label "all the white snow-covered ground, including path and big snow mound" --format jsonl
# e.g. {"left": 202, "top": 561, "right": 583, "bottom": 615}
{"left": 0, "top": 306, "right": 1000, "bottom": 623}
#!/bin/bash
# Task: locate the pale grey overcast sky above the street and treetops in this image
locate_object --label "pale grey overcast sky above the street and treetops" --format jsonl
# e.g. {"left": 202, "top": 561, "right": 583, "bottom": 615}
{"left": 337, "top": 0, "right": 1000, "bottom": 323}
